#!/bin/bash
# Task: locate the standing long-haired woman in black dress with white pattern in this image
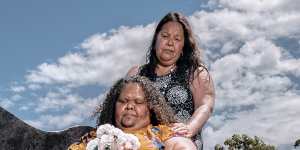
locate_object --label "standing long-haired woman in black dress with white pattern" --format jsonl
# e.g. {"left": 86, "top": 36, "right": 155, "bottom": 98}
{"left": 127, "top": 12, "right": 215, "bottom": 150}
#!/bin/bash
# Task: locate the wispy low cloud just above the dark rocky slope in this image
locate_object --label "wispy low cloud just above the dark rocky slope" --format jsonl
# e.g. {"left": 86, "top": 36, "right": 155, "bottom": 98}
{"left": 26, "top": 93, "right": 102, "bottom": 131}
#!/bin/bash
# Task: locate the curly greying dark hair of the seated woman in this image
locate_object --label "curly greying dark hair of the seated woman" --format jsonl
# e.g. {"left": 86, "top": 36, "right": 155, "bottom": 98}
{"left": 96, "top": 75, "right": 177, "bottom": 126}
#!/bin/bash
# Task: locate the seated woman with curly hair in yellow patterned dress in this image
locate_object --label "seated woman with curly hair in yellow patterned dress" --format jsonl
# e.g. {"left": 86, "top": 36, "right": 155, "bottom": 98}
{"left": 69, "top": 76, "right": 196, "bottom": 150}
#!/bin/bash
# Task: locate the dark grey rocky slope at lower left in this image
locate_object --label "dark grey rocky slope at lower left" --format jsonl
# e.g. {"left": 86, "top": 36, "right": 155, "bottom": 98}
{"left": 0, "top": 107, "right": 93, "bottom": 150}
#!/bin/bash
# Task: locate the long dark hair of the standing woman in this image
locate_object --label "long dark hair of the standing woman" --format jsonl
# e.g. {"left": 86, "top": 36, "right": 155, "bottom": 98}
{"left": 140, "top": 12, "right": 206, "bottom": 84}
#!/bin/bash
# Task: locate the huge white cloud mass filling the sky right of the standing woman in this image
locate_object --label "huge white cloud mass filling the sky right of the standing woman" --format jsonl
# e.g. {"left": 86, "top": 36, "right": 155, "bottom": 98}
{"left": 197, "top": 0, "right": 300, "bottom": 149}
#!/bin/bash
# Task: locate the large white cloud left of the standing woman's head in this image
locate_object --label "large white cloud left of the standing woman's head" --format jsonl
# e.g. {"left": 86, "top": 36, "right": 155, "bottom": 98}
{"left": 26, "top": 24, "right": 154, "bottom": 86}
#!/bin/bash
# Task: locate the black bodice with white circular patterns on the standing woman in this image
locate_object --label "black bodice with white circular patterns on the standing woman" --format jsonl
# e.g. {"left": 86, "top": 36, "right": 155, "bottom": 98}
{"left": 154, "top": 72, "right": 194, "bottom": 122}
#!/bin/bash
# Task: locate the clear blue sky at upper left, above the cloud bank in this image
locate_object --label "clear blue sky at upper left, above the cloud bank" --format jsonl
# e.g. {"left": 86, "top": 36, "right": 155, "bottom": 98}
{"left": 0, "top": 0, "right": 206, "bottom": 85}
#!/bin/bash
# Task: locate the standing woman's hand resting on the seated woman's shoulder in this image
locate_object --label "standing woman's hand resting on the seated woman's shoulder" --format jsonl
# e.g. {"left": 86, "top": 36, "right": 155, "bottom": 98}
{"left": 172, "top": 123, "right": 193, "bottom": 138}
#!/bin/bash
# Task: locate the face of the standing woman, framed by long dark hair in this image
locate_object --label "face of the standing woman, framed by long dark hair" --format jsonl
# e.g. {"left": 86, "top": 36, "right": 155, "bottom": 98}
{"left": 155, "top": 21, "right": 184, "bottom": 66}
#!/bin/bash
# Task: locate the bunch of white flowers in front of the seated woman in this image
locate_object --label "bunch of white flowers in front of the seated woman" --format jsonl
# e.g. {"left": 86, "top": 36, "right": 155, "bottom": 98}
{"left": 86, "top": 124, "right": 140, "bottom": 150}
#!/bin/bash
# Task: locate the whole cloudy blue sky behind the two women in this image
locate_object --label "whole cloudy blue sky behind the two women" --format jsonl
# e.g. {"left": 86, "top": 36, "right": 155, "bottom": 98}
{"left": 0, "top": 0, "right": 300, "bottom": 149}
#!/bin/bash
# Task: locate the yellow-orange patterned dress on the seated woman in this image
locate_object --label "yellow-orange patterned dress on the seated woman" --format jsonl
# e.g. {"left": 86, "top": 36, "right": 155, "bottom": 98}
{"left": 68, "top": 125, "right": 174, "bottom": 150}
